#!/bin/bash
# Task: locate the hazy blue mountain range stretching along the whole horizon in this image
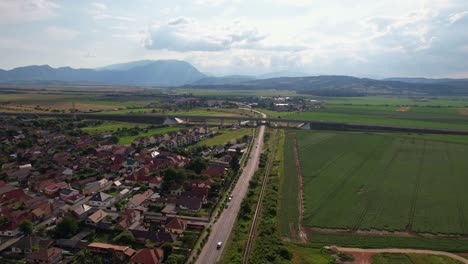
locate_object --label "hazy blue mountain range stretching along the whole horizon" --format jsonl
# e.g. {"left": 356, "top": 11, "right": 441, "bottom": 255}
{"left": 0, "top": 60, "right": 468, "bottom": 96}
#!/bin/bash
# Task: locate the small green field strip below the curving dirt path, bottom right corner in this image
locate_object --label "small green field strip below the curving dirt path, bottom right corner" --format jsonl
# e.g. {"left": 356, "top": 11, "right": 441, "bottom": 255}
{"left": 372, "top": 253, "right": 461, "bottom": 264}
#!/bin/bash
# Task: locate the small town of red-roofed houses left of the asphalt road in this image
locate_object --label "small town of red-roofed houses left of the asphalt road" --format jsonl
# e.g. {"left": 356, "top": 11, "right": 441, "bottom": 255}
{"left": 0, "top": 118, "right": 250, "bottom": 263}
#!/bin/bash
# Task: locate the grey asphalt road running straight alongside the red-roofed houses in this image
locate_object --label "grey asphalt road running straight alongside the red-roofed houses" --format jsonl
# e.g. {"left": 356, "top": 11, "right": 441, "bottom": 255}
{"left": 196, "top": 113, "right": 266, "bottom": 264}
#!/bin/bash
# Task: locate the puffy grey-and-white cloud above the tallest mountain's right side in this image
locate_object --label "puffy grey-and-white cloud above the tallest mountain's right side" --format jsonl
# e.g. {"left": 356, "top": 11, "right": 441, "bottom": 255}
{"left": 144, "top": 18, "right": 266, "bottom": 52}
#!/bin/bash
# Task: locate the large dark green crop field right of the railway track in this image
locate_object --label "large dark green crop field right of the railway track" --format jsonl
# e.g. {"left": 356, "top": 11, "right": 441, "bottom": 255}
{"left": 281, "top": 131, "right": 468, "bottom": 235}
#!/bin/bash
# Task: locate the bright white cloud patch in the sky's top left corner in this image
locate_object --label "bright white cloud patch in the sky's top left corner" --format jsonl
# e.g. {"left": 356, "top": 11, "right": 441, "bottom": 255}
{"left": 0, "top": 0, "right": 59, "bottom": 24}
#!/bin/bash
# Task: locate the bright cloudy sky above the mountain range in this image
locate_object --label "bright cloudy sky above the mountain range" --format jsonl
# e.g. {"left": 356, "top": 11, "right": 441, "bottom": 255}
{"left": 0, "top": 0, "right": 468, "bottom": 78}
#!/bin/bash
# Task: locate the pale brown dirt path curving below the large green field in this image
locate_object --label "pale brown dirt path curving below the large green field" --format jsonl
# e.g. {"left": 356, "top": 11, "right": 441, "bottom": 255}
{"left": 335, "top": 247, "right": 468, "bottom": 264}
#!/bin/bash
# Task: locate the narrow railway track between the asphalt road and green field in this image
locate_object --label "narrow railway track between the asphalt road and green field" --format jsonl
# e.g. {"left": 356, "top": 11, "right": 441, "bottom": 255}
{"left": 242, "top": 129, "right": 278, "bottom": 264}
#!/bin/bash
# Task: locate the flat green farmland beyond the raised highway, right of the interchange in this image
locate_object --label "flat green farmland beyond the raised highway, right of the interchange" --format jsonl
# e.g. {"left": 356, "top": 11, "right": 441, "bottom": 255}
{"left": 265, "top": 97, "right": 468, "bottom": 130}
